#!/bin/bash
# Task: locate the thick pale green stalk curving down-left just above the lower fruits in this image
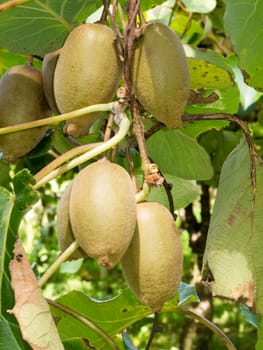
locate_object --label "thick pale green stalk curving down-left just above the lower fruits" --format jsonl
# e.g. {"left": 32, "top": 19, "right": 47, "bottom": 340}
{"left": 33, "top": 113, "right": 131, "bottom": 190}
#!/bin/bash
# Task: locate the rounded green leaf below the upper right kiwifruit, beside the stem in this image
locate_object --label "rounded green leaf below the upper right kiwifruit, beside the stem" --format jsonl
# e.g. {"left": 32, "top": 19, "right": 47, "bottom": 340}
{"left": 147, "top": 128, "right": 213, "bottom": 180}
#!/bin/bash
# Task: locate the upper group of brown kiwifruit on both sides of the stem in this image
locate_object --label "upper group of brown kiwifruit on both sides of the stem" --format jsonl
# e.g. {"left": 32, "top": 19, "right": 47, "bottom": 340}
{"left": 0, "top": 18, "right": 189, "bottom": 162}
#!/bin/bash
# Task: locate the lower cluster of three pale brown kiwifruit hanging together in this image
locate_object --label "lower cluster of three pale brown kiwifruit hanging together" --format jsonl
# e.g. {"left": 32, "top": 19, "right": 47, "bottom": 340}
{"left": 57, "top": 159, "right": 182, "bottom": 312}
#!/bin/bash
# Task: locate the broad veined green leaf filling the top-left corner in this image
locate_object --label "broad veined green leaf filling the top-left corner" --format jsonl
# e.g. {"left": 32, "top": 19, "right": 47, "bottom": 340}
{"left": 0, "top": 0, "right": 101, "bottom": 56}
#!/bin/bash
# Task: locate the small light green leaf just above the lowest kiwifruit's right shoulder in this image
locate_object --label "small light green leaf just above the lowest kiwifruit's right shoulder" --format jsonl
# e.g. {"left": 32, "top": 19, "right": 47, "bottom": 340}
{"left": 147, "top": 174, "right": 201, "bottom": 210}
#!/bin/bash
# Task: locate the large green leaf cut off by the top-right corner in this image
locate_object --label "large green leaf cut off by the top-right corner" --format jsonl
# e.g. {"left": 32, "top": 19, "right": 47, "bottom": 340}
{"left": 224, "top": 0, "right": 263, "bottom": 90}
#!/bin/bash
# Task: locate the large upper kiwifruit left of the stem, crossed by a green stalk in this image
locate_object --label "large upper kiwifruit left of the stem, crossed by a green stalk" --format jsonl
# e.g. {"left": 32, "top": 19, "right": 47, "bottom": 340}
{"left": 54, "top": 23, "right": 121, "bottom": 136}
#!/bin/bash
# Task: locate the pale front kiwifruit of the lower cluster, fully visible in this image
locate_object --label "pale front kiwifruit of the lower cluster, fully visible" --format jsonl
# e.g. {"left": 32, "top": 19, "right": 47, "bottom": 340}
{"left": 69, "top": 160, "right": 136, "bottom": 268}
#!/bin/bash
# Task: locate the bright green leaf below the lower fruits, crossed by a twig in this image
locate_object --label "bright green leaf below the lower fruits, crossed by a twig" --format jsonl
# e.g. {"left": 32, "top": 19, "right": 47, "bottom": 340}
{"left": 51, "top": 289, "right": 152, "bottom": 349}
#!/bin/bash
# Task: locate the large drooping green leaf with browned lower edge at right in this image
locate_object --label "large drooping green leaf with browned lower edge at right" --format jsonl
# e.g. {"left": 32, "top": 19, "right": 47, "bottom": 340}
{"left": 204, "top": 138, "right": 263, "bottom": 315}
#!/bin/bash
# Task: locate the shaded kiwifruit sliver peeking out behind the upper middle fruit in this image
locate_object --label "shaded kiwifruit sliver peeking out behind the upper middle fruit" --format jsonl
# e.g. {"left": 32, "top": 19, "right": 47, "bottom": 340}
{"left": 42, "top": 49, "right": 61, "bottom": 114}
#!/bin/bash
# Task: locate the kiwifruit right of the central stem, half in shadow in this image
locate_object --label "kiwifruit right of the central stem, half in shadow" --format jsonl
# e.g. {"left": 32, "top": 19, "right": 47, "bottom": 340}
{"left": 133, "top": 23, "right": 190, "bottom": 128}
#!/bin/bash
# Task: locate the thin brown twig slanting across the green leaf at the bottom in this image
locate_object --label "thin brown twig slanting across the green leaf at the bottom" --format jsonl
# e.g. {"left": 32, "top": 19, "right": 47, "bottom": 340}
{"left": 47, "top": 299, "right": 120, "bottom": 350}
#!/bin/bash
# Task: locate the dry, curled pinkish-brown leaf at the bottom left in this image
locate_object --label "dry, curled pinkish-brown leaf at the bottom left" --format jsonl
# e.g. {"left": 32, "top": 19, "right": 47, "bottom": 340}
{"left": 9, "top": 240, "right": 64, "bottom": 350}
